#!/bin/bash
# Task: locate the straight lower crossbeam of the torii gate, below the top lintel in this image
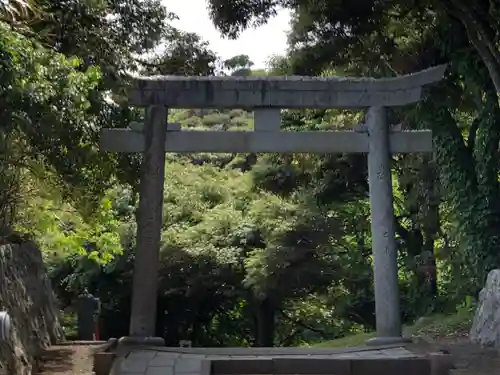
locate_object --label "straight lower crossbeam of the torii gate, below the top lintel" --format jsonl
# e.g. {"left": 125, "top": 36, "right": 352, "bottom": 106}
{"left": 100, "top": 129, "right": 432, "bottom": 153}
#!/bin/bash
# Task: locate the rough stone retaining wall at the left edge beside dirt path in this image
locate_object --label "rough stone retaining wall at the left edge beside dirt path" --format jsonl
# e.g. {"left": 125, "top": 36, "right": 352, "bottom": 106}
{"left": 0, "top": 242, "right": 62, "bottom": 375}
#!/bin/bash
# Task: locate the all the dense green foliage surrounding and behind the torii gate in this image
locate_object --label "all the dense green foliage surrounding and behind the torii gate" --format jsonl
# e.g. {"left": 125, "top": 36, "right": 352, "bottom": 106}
{"left": 0, "top": 0, "right": 500, "bottom": 346}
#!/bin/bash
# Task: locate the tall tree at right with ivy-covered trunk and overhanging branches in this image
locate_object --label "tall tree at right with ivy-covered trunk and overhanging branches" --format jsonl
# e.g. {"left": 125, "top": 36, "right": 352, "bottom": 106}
{"left": 209, "top": 0, "right": 500, "bottom": 294}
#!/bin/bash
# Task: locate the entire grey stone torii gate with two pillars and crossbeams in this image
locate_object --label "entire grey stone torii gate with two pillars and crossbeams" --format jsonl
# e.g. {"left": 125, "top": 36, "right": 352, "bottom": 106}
{"left": 101, "top": 65, "right": 446, "bottom": 345}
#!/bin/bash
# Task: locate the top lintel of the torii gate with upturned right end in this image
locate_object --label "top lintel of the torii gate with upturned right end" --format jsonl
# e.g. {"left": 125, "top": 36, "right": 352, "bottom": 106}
{"left": 128, "top": 65, "right": 447, "bottom": 108}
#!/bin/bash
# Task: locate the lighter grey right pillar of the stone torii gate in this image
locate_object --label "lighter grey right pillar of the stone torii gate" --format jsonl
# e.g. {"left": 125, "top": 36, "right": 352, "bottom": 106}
{"left": 366, "top": 107, "right": 404, "bottom": 345}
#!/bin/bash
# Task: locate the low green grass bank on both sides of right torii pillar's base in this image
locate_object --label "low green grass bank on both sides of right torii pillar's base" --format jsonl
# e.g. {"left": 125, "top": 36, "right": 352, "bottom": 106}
{"left": 311, "top": 308, "right": 474, "bottom": 348}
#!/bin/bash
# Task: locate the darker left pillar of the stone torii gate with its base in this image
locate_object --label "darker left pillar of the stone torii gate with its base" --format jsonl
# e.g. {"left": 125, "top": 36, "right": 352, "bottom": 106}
{"left": 120, "top": 105, "right": 168, "bottom": 346}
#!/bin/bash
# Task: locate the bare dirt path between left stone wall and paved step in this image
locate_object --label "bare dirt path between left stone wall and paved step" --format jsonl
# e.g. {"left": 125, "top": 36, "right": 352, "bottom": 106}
{"left": 38, "top": 345, "right": 95, "bottom": 375}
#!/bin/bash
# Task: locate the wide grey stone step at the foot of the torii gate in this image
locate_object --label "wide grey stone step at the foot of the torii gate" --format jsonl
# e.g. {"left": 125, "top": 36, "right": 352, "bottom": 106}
{"left": 112, "top": 350, "right": 453, "bottom": 375}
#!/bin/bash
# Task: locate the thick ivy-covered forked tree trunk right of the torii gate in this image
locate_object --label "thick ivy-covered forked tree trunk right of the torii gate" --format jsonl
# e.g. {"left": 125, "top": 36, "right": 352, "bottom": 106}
{"left": 423, "top": 99, "right": 500, "bottom": 296}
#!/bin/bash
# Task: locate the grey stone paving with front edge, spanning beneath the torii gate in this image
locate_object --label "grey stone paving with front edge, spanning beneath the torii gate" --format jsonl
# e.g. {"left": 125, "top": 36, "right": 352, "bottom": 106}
{"left": 111, "top": 346, "right": 438, "bottom": 375}
